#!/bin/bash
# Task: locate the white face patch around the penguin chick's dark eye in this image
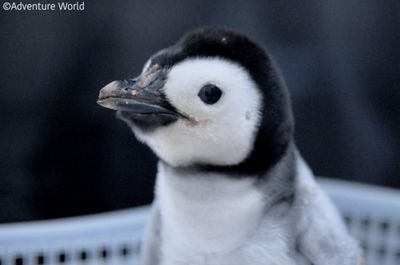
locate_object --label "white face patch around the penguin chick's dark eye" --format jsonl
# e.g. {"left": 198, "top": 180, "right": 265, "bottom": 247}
{"left": 134, "top": 58, "right": 261, "bottom": 166}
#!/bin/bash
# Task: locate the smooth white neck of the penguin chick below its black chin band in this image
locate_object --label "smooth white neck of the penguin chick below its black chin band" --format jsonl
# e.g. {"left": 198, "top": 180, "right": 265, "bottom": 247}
{"left": 156, "top": 147, "right": 291, "bottom": 254}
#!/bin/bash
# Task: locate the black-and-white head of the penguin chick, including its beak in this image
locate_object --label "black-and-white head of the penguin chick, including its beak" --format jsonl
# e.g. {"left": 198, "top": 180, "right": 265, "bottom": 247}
{"left": 98, "top": 28, "right": 293, "bottom": 174}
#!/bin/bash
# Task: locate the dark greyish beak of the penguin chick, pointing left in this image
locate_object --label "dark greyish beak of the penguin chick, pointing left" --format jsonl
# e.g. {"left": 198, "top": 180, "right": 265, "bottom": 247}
{"left": 97, "top": 66, "right": 183, "bottom": 124}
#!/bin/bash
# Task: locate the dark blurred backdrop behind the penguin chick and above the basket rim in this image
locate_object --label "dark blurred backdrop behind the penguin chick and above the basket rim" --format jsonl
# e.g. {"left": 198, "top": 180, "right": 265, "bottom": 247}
{"left": 0, "top": 0, "right": 400, "bottom": 222}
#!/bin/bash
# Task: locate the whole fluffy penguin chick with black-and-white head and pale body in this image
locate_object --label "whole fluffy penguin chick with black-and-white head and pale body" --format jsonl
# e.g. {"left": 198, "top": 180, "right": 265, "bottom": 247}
{"left": 98, "top": 28, "right": 361, "bottom": 265}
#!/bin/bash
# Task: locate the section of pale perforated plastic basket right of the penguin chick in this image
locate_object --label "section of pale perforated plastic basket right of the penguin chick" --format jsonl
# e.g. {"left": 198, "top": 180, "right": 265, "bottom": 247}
{"left": 318, "top": 179, "right": 400, "bottom": 265}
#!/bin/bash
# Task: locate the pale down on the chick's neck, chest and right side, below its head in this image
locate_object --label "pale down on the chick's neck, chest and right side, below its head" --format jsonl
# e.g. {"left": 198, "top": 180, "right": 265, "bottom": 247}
{"left": 152, "top": 155, "right": 361, "bottom": 265}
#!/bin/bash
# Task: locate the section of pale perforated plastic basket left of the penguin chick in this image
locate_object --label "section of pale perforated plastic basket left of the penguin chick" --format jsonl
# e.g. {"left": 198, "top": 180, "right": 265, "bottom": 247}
{"left": 0, "top": 207, "right": 148, "bottom": 265}
